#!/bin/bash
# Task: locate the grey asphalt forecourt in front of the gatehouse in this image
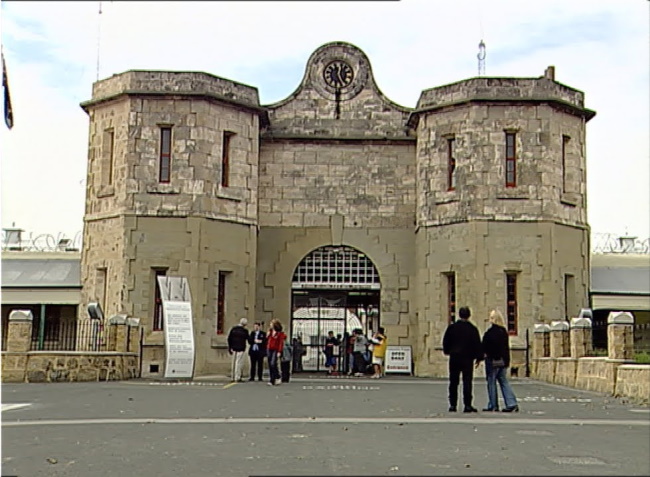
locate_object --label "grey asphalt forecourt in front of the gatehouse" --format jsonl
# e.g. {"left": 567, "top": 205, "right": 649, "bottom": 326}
{"left": 2, "top": 376, "right": 650, "bottom": 477}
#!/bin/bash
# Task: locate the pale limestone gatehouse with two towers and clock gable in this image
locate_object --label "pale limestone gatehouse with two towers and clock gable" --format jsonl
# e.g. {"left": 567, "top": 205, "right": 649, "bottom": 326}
{"left": 81, "top": 42, "right": 595, "bottom": 376}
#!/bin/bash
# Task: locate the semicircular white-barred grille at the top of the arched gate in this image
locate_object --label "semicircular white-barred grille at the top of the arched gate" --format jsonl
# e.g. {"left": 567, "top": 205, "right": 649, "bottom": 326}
{"left": 292, "top": 246, "right": 380, "bottom": 290}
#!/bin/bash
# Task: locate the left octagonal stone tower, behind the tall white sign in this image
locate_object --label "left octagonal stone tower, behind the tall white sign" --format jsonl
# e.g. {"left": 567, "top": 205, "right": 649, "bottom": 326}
{"left": 82, "top": 71, "right": 263, "bottom": 374}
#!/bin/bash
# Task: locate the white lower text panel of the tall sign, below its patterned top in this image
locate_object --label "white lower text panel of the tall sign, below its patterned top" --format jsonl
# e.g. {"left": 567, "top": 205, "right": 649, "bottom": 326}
{"left": 163, "top": 300, "right": 194, "bottom": 378}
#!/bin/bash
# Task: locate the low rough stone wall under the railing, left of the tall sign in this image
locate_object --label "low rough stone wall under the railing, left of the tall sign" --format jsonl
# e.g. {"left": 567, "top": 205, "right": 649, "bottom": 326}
{"left": 2, "top": 351, "right": 139, "bottom": 383}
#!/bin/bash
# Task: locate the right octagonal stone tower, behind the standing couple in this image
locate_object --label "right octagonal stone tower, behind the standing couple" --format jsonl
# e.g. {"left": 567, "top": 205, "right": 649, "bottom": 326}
{"left": 409, "top": 67, "right": 595, "bottom": 375}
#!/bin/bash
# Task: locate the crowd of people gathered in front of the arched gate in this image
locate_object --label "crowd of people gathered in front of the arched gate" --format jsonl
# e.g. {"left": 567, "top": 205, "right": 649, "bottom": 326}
{"left": 228, "top": 318, "right": 388, "bottom": 386}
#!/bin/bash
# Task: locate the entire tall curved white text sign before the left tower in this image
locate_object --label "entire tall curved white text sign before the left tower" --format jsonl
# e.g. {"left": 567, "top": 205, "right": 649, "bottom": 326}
{"left": 158, "top": 277, "right": 195, "bottom": 378}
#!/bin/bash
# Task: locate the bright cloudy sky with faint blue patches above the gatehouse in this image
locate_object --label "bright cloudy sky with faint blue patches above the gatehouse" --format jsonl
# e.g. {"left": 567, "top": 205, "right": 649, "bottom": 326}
{"left": 0, "top": 0, "right": 650, "bottom": 245}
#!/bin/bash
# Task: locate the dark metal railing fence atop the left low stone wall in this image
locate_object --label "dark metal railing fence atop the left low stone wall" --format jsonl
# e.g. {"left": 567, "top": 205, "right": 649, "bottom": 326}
{"left": 31, "top": 320, "right": 115, "bottom": 351}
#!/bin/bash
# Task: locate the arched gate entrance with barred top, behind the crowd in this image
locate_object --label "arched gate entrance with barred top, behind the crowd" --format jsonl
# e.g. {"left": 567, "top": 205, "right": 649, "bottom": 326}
{"left": 291, "top": 246, "right": 381, "bottom": 371}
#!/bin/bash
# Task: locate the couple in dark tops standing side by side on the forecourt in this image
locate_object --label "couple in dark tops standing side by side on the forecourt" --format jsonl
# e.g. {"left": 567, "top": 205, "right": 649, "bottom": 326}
{"left": 442, "top": 307, "right": 519, "bottom": 412}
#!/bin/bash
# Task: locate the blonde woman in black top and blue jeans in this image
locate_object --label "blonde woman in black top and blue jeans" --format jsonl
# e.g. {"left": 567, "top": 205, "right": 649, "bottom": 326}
{"left": 483, "top": 310, "right": 519, "bottom": 412}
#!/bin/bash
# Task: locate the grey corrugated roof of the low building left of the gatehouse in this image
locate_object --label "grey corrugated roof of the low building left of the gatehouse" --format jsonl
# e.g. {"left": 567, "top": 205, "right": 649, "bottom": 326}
{"left": 2, "top": 258, "right": 81, "bottom": 288}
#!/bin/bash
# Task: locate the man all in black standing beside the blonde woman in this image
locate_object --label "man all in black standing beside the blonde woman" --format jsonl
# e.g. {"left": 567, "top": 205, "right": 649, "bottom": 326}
{"left": 442, "top": 306, "right": 483, "bottom": 412}
